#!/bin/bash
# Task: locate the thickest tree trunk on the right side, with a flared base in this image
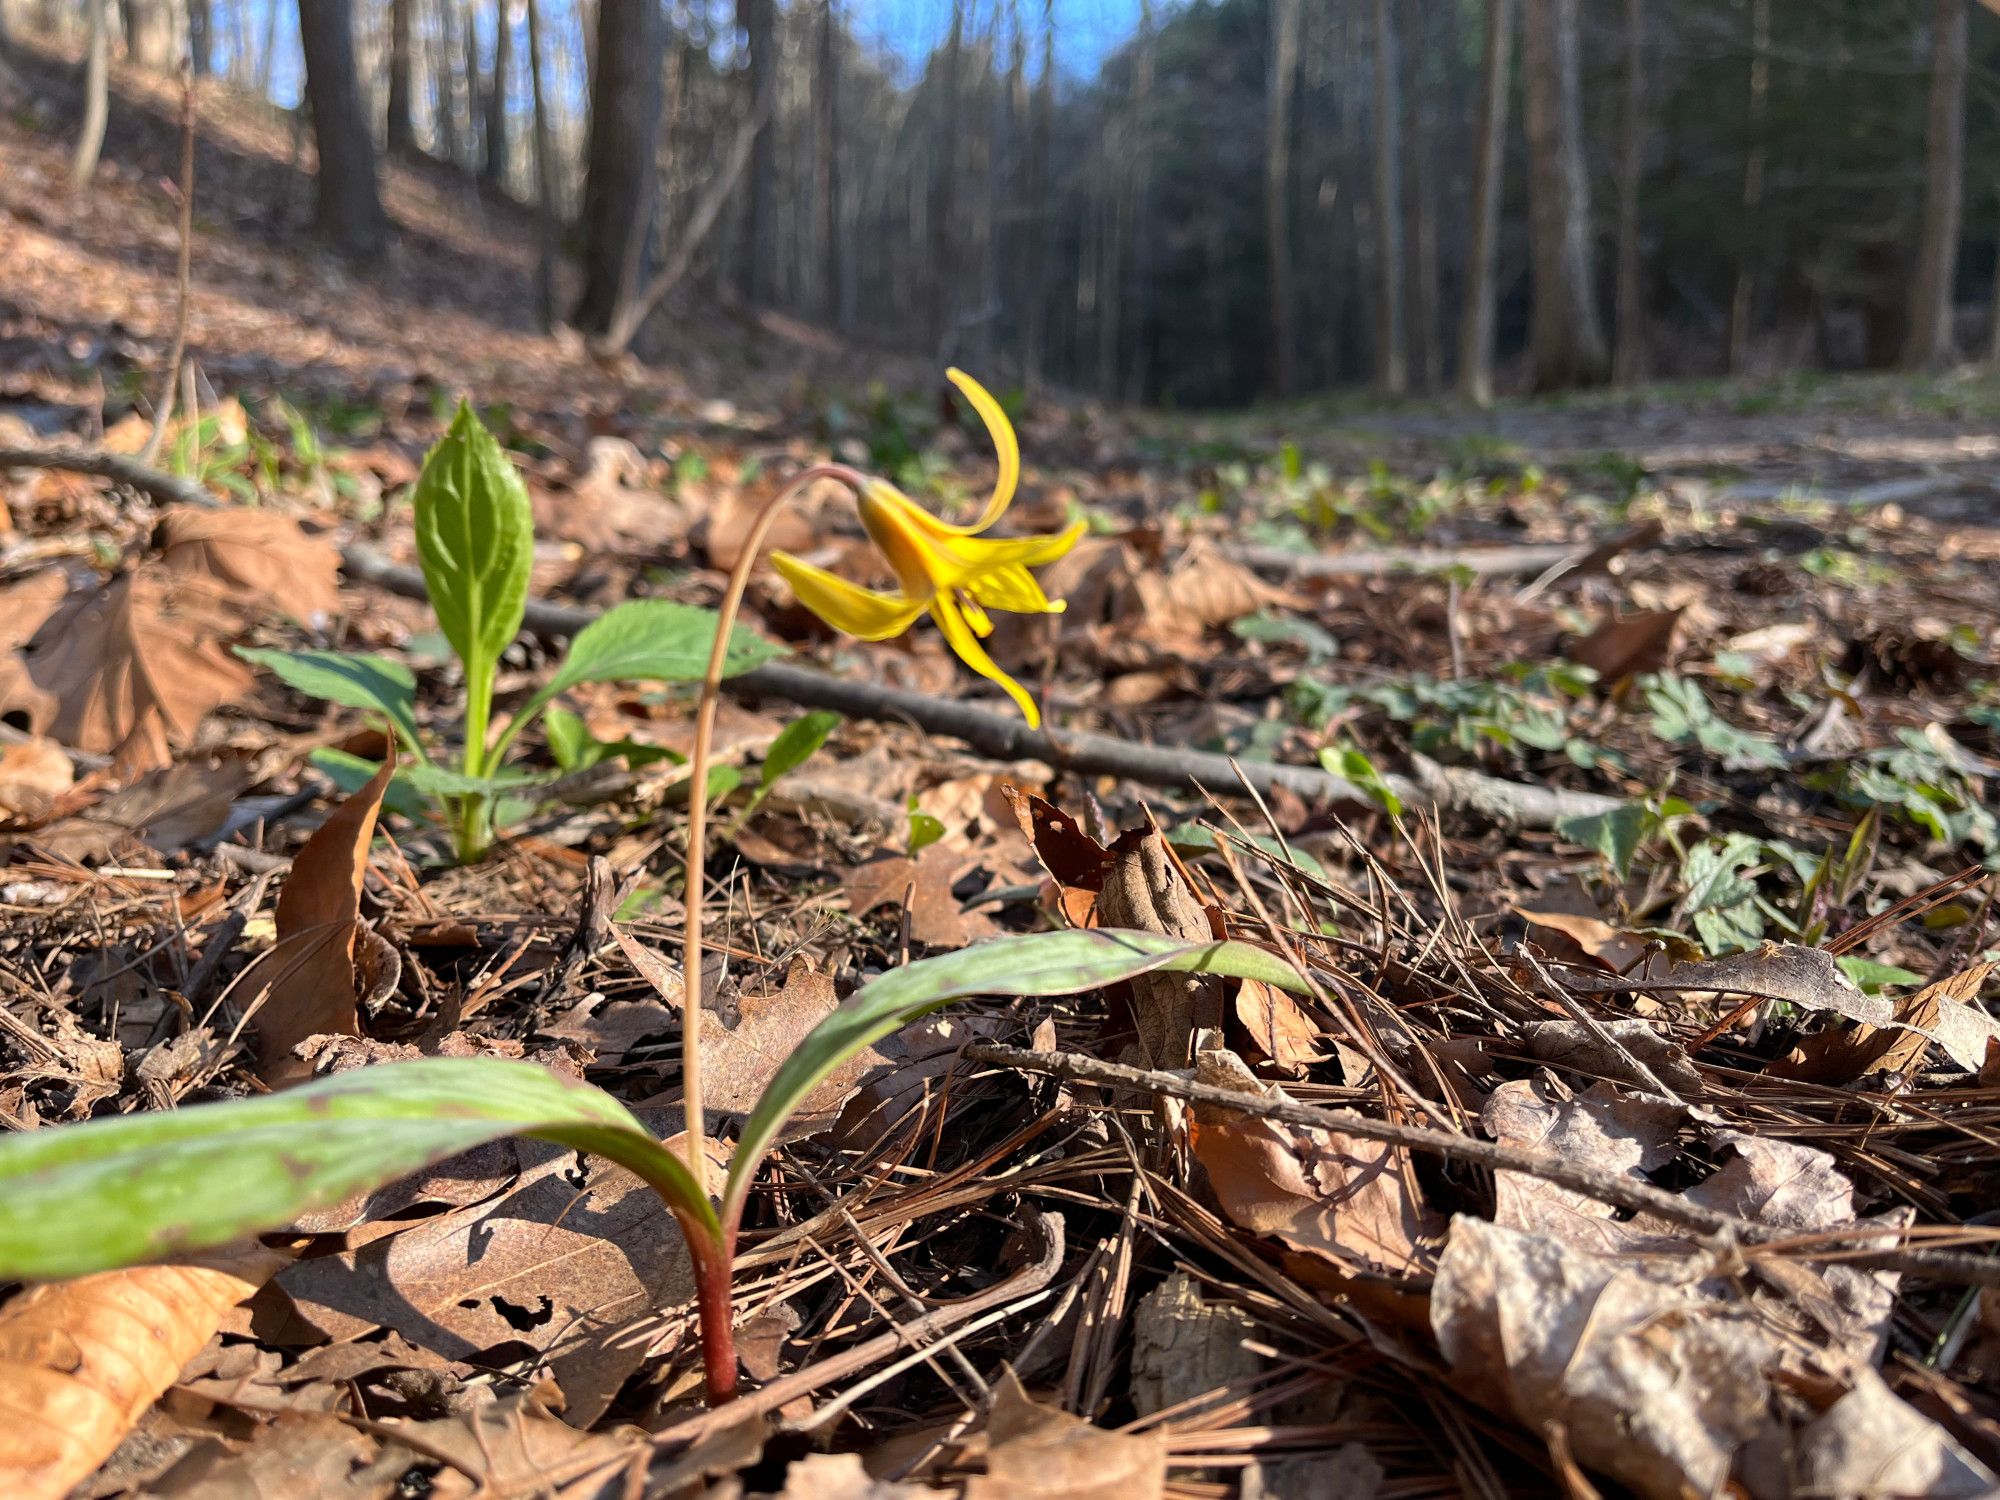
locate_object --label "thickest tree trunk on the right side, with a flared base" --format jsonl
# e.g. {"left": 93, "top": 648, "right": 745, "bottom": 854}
{"left": 1522, "top": 0, "right": 1610, "bottom": 390}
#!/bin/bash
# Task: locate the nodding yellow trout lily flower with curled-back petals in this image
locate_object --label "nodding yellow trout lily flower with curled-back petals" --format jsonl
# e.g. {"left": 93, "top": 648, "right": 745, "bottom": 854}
{"left": 770, "top": 370, "right": 1084, "bottom": 728}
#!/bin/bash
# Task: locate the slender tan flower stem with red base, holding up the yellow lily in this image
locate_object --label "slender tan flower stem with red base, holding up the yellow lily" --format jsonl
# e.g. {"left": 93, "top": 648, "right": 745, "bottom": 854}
{"left": 680, "top": 464, "right": 868, "bottom": 1406}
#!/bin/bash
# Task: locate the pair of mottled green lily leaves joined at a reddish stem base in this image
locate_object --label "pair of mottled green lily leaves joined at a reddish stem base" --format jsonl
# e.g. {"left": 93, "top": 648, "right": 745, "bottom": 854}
{"left": 0, "top": 930, "right": 1304, "bottom": 1402}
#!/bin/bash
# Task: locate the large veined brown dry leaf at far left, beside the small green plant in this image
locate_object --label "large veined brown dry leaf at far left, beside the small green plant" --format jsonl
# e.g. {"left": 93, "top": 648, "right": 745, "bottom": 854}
{"left": 22, "top": 570, "right": 250, "bottom": 770}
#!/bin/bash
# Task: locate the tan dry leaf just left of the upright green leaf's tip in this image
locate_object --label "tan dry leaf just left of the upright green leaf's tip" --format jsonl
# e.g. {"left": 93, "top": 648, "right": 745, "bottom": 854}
{"left": 156, "top": 506, "right": 340, "bottom": 626}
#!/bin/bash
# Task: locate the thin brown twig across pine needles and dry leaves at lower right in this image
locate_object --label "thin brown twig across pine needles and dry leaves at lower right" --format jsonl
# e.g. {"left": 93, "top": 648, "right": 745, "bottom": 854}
{"left": 960, "top": 1042, "right": 2000, "bottom": 1286}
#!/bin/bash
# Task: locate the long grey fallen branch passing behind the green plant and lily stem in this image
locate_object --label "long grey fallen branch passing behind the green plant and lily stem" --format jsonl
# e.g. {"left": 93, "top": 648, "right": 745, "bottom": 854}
{"left": 0, "top": 448, "right": 1618, "bottom": 828}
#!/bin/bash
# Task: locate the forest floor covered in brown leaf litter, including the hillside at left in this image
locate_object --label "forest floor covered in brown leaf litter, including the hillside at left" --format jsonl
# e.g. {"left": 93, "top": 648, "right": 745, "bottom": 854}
{"left": 0, "top": 47, "right": 2000, "bottom": 1500}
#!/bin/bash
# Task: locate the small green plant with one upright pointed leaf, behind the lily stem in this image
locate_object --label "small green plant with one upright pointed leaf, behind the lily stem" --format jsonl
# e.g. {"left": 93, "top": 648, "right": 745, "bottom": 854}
{"left": 240, "top": 404, "right": 792, "bottom": 860}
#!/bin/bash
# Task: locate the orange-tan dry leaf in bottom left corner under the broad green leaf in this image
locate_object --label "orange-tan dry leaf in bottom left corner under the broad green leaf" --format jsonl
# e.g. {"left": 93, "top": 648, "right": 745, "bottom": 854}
{"left": 0, "top": 1248, "right": 284, "bottom": 1500}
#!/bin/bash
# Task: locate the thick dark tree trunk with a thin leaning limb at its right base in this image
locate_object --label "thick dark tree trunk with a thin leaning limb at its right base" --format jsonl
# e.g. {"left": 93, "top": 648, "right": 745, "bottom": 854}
{"left": 572, "top": 0, "right": 664, "bottom": 334}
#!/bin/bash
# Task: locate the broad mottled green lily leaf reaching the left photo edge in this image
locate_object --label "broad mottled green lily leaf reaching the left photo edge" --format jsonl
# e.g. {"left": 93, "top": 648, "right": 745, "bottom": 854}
{"left": 0, "top": 1058, "right": 720, "bottom": 1280}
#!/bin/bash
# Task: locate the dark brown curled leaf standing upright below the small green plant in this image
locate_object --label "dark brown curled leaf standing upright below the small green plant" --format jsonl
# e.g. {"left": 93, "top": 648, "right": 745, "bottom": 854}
{"left": 240, "top": 752, "right": 396, "bottom": 1084}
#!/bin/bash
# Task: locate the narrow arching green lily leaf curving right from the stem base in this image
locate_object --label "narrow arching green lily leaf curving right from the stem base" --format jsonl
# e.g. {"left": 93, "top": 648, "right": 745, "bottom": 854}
{"left": 722, "top": 928, "right": 1306, "bottom": 1224}
